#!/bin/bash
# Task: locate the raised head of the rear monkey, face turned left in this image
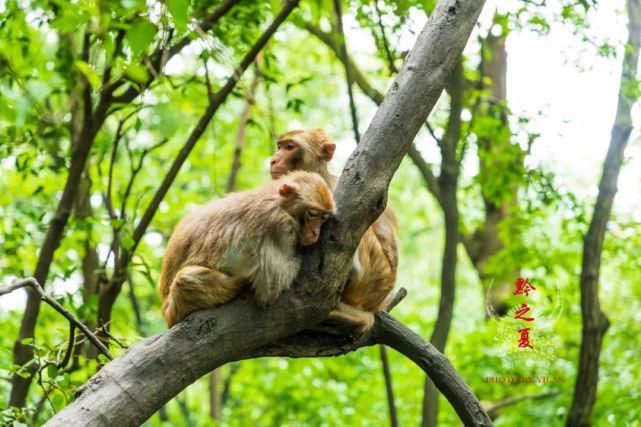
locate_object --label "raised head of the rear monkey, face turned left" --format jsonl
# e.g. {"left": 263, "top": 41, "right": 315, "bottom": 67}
{"left": 270, "top": 129, "right": 336, "bottom": 179}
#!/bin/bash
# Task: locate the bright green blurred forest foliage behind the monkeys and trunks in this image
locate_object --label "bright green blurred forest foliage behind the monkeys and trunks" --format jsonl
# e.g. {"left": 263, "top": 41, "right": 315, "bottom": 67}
{"left": 0, "top": 0, "right": 641, "bottom": 426}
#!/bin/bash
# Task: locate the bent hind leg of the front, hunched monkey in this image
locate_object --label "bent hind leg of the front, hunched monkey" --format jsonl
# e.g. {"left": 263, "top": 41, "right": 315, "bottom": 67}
{"left": 162, "top": 266, "right": 243, "bottom": 327}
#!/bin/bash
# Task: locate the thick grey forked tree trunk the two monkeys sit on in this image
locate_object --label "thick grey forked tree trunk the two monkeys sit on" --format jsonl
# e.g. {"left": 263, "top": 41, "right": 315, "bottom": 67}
{"left": 43, "top": 0, "right": 490, "bottom": 426}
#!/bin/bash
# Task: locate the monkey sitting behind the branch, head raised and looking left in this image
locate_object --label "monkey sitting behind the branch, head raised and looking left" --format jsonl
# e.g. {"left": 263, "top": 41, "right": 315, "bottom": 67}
{"left": 270, "top": 129, "right": 398, "bottom": 330}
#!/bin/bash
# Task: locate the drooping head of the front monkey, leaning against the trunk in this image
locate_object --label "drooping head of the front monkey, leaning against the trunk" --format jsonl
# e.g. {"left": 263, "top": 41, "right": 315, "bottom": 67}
{"left": 275, "top": 171, "right": 336, "bottom": 246}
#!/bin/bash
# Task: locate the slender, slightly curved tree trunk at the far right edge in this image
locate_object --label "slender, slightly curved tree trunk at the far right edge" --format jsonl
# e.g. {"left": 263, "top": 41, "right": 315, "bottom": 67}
{"left": 567, "top": 0, "right": 641, "bottom": 427}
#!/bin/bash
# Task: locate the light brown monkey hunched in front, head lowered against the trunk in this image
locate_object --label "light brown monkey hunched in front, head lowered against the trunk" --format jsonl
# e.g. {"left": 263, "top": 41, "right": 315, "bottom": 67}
{"left": 160, "top": 171, "right": 335, "bottom": 326}
